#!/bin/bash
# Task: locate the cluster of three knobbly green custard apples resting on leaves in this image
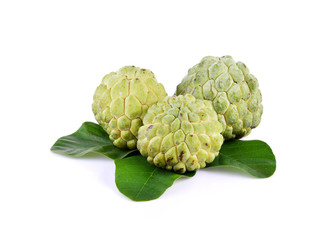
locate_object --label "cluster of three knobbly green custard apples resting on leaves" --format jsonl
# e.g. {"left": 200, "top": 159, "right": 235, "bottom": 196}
{"left": 92, "top": 56, "right": 263, "bottom": 173}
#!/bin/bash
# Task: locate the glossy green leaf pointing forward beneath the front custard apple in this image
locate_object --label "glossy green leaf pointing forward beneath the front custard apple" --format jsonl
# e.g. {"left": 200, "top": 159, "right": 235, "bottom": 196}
{"left": 115, "top": 155, "right": 195, "bottom": 201}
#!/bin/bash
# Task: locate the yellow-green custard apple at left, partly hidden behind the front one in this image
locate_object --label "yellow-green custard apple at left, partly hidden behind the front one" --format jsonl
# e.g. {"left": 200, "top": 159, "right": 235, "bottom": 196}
{"left": 92, "top": 66, "right": 167, "bottom": 149}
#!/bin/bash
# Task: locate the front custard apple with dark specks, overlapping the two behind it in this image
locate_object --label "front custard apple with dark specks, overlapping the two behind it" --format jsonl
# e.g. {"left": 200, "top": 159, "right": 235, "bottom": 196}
{"left": 137, "top": 94, "right": 223, "bottom": 173}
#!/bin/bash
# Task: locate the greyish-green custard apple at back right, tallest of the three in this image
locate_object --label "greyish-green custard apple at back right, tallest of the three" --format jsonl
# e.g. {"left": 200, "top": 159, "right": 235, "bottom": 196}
{"left": 176, "top": 56, "right": 263, "bottom": 140}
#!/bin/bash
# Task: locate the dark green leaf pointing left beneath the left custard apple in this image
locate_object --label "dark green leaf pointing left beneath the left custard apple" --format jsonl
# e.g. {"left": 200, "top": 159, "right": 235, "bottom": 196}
{"left": 51, "top": 122, "right": 138, "bottom": 159}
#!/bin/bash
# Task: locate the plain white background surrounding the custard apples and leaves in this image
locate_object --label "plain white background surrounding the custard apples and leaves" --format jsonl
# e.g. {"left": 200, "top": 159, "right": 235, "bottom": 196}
{"left": 0, "top": 0, "right": 331, "bottom": 240}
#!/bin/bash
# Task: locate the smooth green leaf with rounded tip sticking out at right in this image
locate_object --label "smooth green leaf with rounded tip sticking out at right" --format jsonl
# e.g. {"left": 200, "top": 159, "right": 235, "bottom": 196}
{"left": 206, "top": 140, "right": 276, "bottom": 178}
